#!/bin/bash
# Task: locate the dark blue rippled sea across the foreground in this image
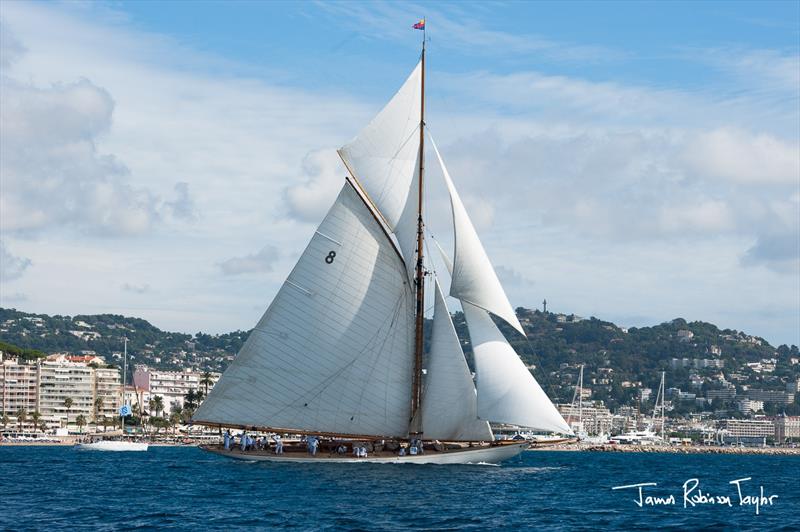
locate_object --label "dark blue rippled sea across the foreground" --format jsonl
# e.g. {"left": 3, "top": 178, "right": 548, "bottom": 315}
{"left": 0, "top": 447, "right": 800, "bottom": 531}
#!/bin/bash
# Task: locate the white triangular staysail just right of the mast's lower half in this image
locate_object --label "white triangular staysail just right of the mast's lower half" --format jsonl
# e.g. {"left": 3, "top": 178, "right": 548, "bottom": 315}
{"left": 421, "top": 280, "right": 494, "bottom": 441}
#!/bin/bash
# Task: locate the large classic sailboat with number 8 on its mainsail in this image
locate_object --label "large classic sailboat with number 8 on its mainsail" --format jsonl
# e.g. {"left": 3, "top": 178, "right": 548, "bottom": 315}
{"left": 193, "top": 39, "right": 572, "bottom": 464}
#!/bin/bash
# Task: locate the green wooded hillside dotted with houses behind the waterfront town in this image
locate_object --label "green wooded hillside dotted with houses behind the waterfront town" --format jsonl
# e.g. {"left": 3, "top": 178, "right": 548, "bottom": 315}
{"left": 0, "top": 308, "right": 800, "bottom": 410}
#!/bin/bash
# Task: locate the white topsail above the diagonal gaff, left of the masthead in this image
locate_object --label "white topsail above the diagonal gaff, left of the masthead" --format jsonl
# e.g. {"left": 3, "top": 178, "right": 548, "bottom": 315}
{"left": 339, "top": 62, "right": 422, "bottom": 232}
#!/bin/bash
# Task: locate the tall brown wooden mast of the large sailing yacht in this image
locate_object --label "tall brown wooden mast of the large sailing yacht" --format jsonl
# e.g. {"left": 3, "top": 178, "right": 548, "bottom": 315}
{"left": 411, "top": 35, "right": 425, "bottom": 433}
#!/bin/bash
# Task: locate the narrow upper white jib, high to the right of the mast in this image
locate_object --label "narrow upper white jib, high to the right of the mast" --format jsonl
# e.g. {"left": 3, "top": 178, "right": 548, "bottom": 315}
{"left": 431, "top": 138, "right": 525, "bottom": 335}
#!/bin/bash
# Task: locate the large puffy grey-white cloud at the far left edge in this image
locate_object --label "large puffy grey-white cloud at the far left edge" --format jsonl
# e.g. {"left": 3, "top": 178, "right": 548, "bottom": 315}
{"left": 0, "top": 79, "right": 158, "bottom": 235}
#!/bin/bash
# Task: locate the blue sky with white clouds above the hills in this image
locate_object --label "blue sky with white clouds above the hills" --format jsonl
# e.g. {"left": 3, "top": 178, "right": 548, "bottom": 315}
{"left": 0, "top": 1, "right": 800, "bottom": 345}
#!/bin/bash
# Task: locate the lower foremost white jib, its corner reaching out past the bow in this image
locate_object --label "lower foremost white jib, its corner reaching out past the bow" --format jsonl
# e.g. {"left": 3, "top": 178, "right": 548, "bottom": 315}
{"left": 462, "top": 301, "right": 572, "bottom": 434}
